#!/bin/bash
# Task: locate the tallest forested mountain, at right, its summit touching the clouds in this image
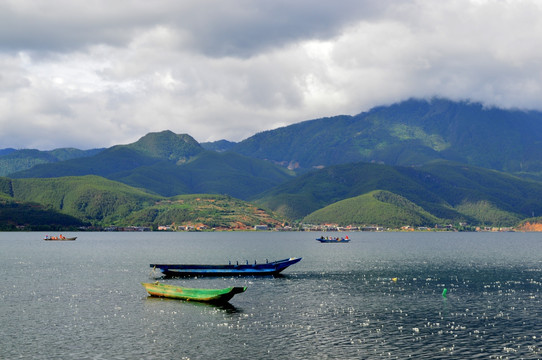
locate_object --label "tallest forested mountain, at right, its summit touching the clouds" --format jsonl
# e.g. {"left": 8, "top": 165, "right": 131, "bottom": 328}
{"left": 232, "top": 99, "right": 542, "bottom": 175}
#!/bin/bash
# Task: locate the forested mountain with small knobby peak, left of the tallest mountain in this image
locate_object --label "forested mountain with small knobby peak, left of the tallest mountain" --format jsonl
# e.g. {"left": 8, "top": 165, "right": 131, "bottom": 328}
{"left": 10, "top": 131, "right": 293, "bottom": 199}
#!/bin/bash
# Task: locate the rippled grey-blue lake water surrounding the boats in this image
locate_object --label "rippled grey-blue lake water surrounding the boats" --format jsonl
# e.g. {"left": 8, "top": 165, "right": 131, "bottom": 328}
{"left": 0, "top": 232, "right": 542, "bottom": 359}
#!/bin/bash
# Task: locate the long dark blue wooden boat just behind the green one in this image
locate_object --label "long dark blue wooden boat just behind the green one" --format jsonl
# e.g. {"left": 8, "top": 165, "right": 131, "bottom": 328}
{"left": 150, "top": 258, "right": 301, "bottom": 276}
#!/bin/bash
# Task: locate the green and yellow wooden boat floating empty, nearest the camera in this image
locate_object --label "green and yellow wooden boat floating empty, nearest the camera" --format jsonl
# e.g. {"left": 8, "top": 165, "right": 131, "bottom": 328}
{"left": 141, "top": 281, "right": 247, "bottom": 303}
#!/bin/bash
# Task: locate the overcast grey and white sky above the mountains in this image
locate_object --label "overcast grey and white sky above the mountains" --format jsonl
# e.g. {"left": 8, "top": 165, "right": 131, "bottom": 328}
{"left": 0, "top": 0, "right": 542, "bottom": 150}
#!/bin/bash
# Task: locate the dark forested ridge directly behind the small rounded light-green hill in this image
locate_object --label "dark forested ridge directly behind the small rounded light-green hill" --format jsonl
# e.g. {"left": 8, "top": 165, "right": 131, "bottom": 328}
{"left": 254, "top": 162, "right": 542, "bottom": 226}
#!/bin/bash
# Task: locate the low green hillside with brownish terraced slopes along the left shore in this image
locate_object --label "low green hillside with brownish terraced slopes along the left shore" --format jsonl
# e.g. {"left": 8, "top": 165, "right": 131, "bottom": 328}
{"left": 0, "top": 175, "right": 284, "bottom": 230}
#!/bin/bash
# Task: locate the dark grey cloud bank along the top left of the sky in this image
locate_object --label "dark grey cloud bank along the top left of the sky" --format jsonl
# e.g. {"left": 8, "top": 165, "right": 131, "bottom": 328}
{"left": 0, "top": 0, "right": 392, "bottom": 56}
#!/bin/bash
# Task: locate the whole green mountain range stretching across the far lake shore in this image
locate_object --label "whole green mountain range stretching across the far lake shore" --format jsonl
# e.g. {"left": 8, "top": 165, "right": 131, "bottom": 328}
{"left": 0, "top": 99, "right": 542, "bottom": 227}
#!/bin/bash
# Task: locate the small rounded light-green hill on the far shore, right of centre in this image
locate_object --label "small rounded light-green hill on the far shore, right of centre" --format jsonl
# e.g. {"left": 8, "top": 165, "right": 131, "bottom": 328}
{"left": 303, "top": 190, "right": 442, "bottom": 228}
